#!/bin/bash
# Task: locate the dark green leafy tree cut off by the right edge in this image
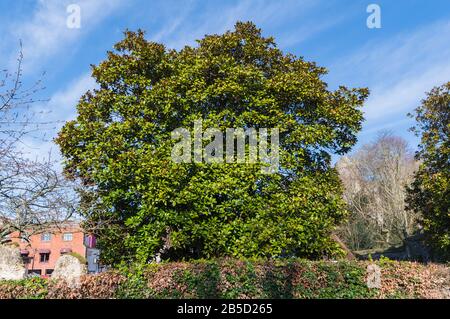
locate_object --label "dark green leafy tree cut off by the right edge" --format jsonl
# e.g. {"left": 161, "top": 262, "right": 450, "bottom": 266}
{"left": 407, "top": 82, "right": 450, "bottom": 259}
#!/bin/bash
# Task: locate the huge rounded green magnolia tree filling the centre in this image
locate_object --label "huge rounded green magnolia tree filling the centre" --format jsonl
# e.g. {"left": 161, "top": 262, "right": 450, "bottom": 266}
{"left": 57, "top": 23, "right": 368, "bottom": 264}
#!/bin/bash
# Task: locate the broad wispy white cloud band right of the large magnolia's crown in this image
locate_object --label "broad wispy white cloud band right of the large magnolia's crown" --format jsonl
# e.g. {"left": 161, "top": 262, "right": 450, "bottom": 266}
{"left": 330, "top": 21, "right": 450, "bottom": 130}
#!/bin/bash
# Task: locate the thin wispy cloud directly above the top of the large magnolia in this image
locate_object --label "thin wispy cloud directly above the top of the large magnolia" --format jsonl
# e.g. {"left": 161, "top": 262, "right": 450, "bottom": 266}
{"left": 150, "top": 0, "right": 334, "bottom": 49}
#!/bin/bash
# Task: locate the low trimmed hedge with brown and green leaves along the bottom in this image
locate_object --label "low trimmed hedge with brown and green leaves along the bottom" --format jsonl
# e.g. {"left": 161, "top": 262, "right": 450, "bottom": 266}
{"left": 0, "top": 259, "right": 450, "bottom": 299}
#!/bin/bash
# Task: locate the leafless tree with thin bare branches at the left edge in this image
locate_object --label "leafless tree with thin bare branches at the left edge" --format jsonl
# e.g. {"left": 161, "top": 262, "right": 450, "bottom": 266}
{"left": 0, "top": 45, "right": 75, "bottom": 243}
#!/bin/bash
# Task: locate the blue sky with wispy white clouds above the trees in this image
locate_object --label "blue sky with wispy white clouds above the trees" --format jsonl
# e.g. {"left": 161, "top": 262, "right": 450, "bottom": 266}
{"left": 0, "top": 0, "right": 450, "bottom": 162}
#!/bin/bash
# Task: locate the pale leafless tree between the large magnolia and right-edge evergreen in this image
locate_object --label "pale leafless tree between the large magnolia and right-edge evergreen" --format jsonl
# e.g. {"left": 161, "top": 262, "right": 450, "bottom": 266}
{"left": 336, "top": 132, "right": 419, "bottom": 250}
